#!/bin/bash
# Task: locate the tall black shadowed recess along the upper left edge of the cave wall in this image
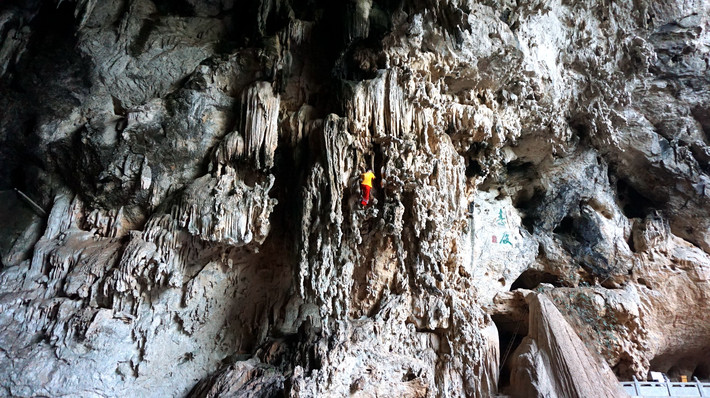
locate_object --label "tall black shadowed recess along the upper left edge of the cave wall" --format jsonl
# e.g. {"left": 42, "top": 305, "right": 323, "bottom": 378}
{"left": 0, "top": 2, "right": 89, "bottom": 197}
